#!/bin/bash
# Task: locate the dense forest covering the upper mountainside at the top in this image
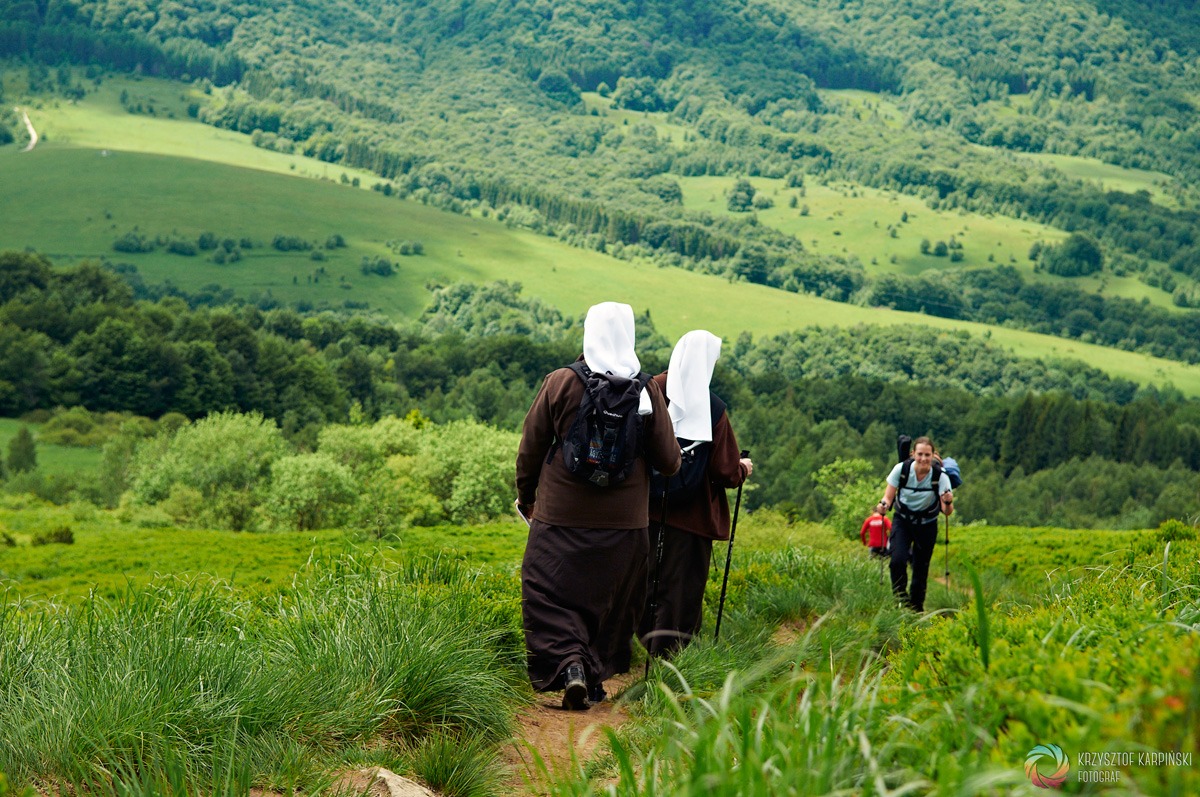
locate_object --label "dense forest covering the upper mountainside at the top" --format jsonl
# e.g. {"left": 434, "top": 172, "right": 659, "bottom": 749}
{"left": 7, "top": 0, "right": 1200, "bottom": 362}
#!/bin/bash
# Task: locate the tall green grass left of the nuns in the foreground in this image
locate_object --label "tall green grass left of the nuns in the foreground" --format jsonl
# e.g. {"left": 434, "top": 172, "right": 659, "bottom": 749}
{"left": 0, "top": 559, "right": 523, "bottom": 793}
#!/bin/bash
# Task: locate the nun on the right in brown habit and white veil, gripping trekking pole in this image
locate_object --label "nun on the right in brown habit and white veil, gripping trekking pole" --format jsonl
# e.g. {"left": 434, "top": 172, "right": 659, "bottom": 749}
{"left": 638, "top": 329, "right": 754, "bottom": 655}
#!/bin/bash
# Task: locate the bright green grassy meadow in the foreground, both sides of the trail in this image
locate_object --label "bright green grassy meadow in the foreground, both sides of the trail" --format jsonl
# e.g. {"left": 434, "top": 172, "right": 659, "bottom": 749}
{"left": 0, "top": 501, "right": 1200, "bottom": 797}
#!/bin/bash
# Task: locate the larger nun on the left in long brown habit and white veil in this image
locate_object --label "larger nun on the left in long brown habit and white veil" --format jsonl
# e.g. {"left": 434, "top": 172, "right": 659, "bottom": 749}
{"left": 516, "top": 302, "right": 679, "bottom": 709}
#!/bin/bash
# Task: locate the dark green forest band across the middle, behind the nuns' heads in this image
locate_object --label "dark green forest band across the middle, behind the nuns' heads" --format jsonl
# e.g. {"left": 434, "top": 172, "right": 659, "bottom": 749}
{"left": 0, "top": 252, "right": 1200, "bottom": 527}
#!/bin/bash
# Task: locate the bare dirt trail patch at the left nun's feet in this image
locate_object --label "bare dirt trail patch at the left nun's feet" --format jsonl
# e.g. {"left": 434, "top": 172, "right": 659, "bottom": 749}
{"left": 504, "top": 672, "right": 641, "bottom": 795}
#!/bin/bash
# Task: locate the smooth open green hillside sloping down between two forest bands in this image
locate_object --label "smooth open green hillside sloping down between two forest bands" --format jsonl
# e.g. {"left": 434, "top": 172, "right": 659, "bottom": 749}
{"left": 7, "top": 142, "right": 1200, "bottom": 395}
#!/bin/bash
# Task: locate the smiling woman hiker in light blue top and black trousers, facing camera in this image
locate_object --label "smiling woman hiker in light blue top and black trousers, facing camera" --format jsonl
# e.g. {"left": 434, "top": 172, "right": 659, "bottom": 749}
{"left": 876, "top": 437, "right": 954, "bottom": 612}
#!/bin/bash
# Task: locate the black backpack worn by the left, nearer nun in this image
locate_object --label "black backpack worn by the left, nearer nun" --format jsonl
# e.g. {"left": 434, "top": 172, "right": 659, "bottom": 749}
{"left": 547, "top": 362, "right": 650, "bottom": 487}
